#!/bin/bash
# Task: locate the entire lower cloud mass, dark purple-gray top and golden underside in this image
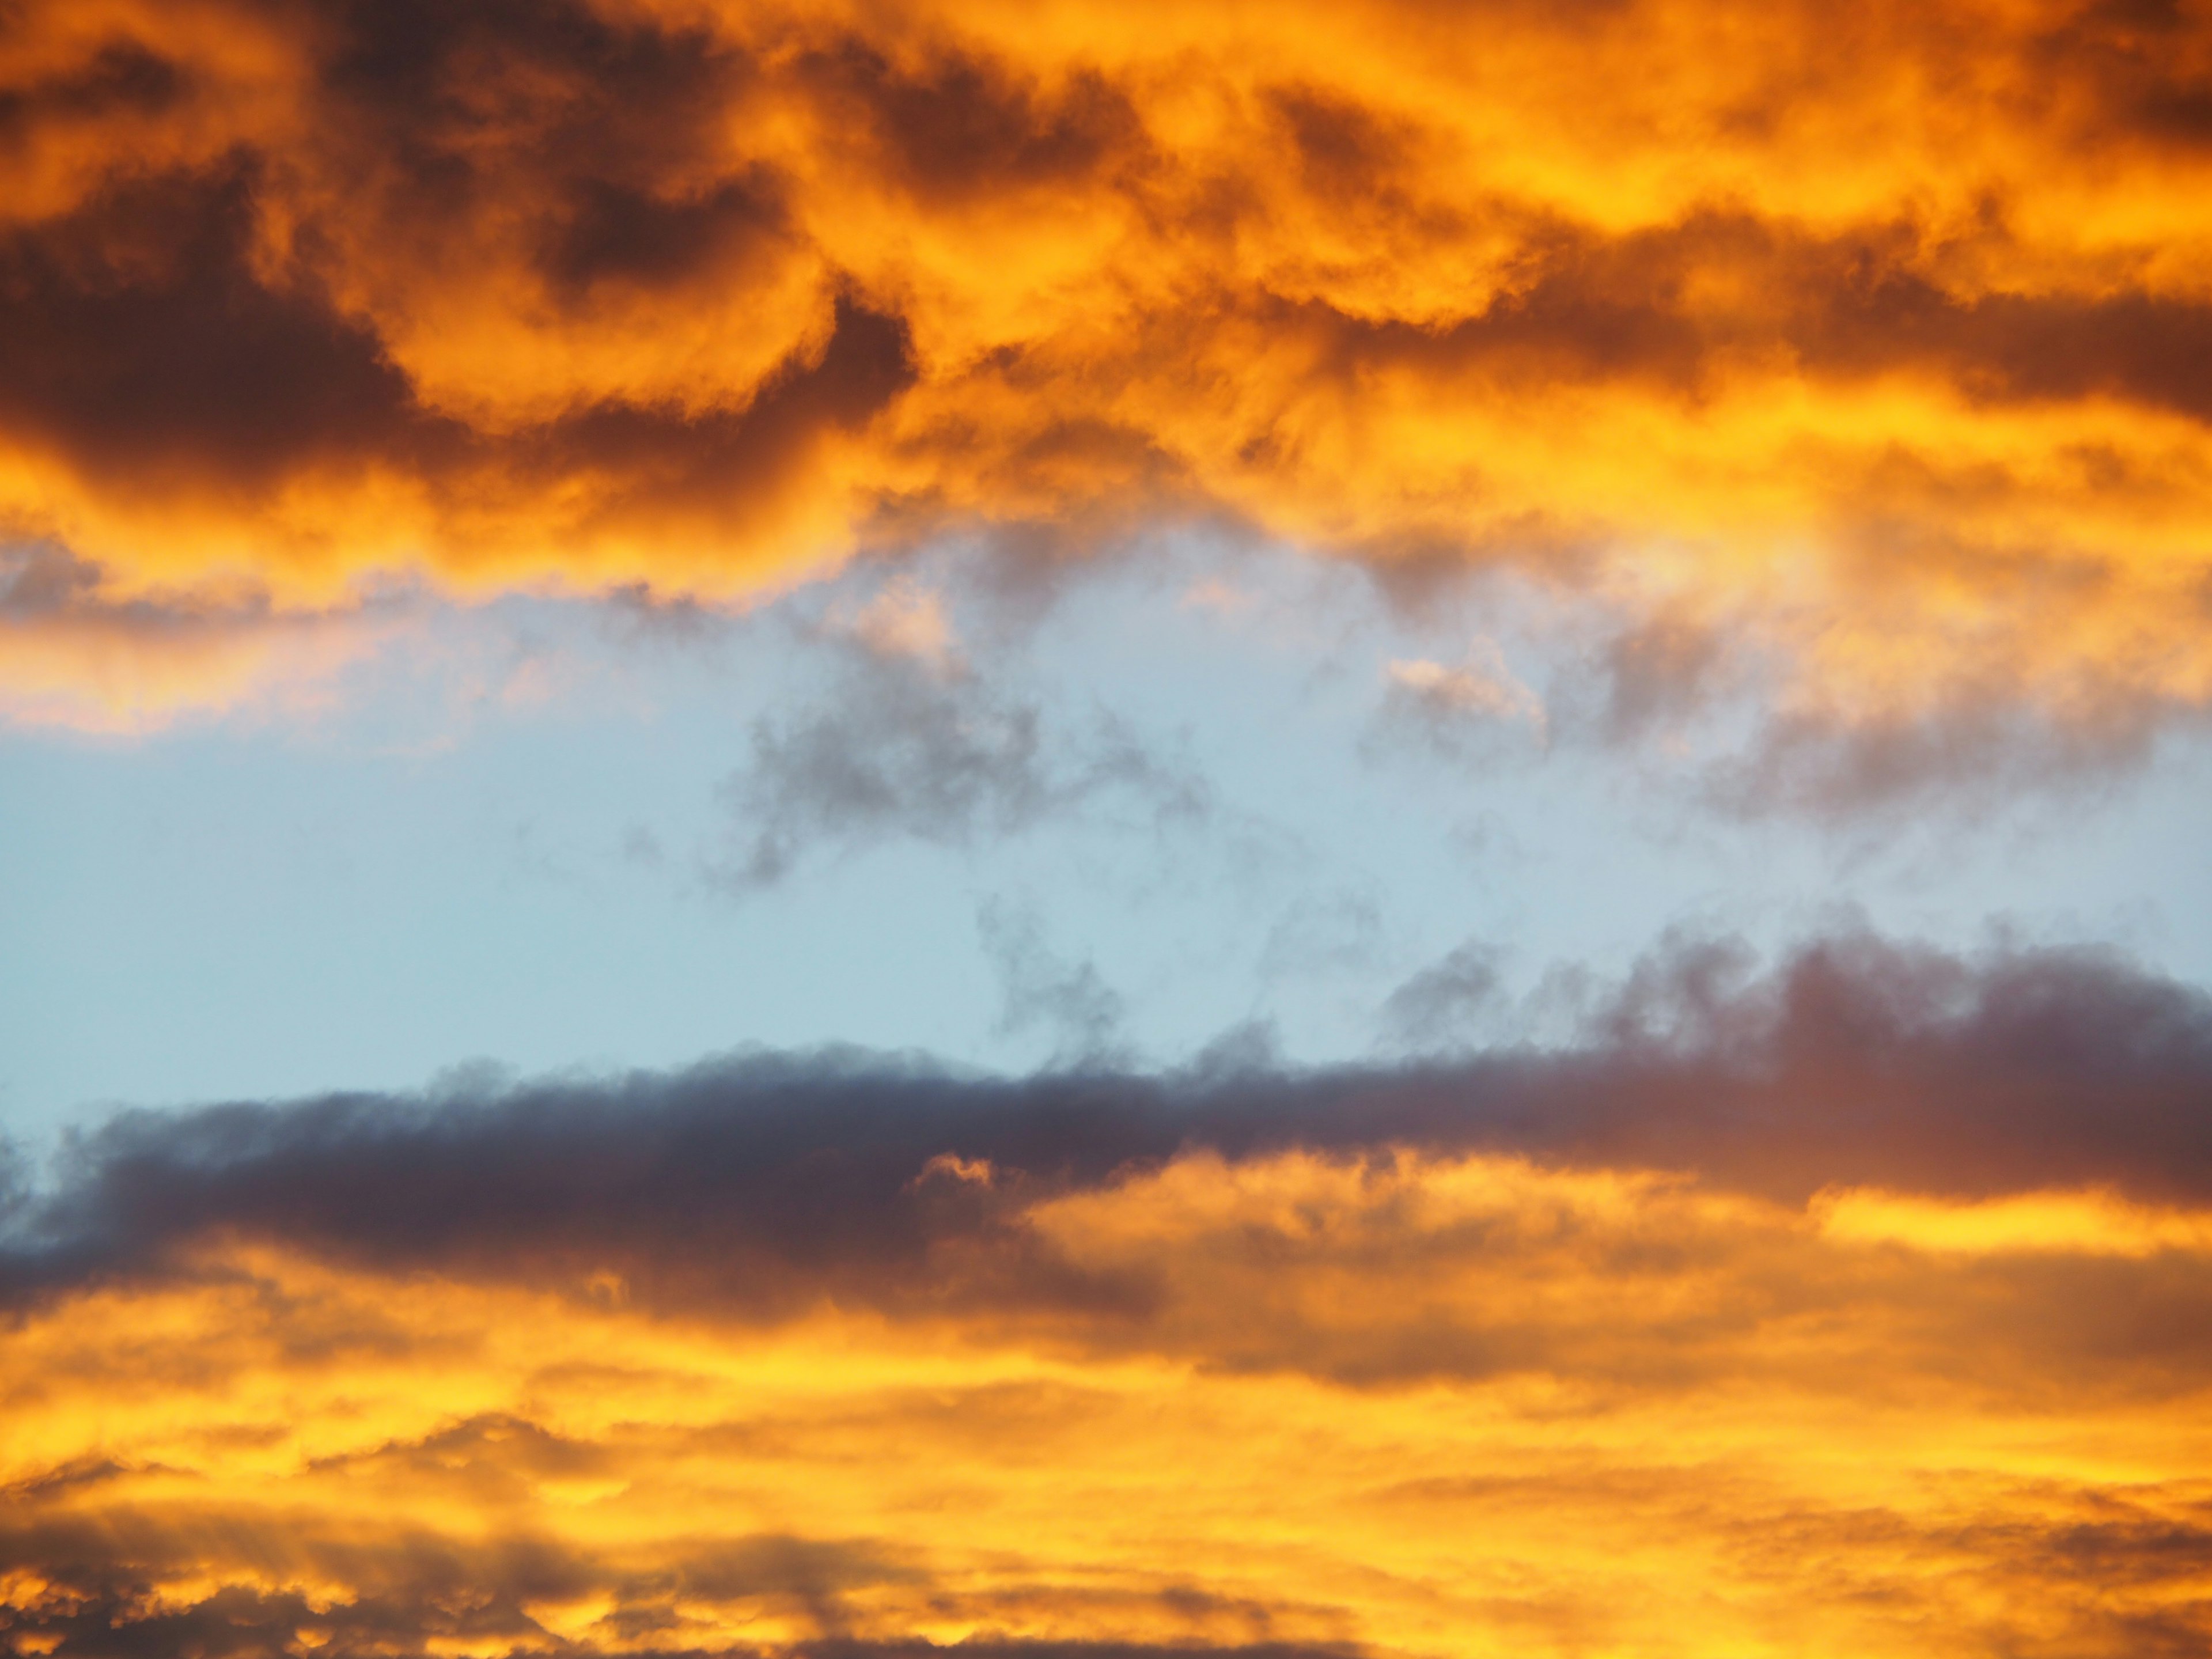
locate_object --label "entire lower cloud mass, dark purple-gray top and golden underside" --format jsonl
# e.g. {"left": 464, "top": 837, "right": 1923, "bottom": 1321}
{"left": 13, "top": 940, "right": 2212, "bottom": 1659}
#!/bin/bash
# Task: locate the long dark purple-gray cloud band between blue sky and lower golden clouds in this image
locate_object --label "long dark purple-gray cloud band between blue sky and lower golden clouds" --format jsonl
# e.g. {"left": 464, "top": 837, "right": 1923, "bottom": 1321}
{"left": 13, "top": 935, "right": 2212, "bottom": 1319}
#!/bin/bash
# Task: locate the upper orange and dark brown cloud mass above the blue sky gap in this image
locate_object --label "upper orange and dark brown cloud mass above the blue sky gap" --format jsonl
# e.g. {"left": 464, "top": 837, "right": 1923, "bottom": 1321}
{"left": 13, "top": 0, "right": 2212, "bottom": 732}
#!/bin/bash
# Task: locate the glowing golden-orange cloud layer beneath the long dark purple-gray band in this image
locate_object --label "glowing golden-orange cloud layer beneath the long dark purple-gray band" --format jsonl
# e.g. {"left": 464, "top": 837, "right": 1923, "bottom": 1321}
{"left": 0, "top": 1153, "right": 2212, "bottom": 1657}
